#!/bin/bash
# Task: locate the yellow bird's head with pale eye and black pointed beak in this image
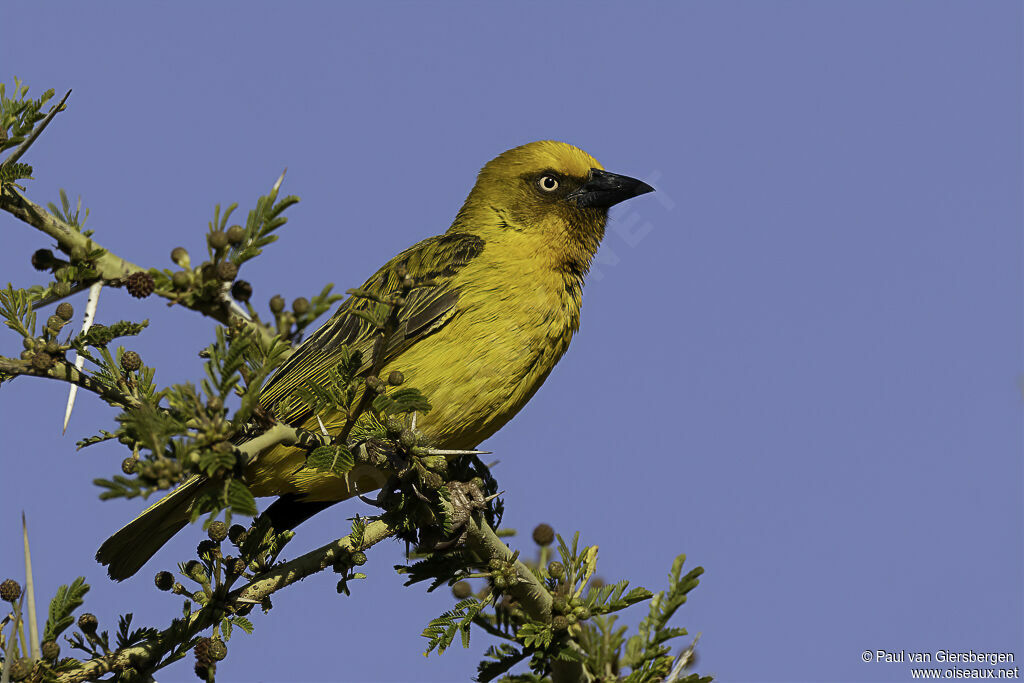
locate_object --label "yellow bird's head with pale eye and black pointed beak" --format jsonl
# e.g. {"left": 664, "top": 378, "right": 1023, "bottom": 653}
{"left": 453, "top": 140, "right": 654, "bottom": 267}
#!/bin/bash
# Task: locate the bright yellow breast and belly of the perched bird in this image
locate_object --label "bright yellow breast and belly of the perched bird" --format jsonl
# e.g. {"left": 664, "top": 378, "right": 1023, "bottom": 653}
{"left": 247, "top": 230, "right": 582, "bottom": 501}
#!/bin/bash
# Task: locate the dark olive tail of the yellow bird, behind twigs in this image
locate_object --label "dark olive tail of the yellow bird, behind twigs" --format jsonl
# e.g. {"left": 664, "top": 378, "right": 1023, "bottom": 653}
{"left": 96, "top": 476, "right": 207, "bottom": 581}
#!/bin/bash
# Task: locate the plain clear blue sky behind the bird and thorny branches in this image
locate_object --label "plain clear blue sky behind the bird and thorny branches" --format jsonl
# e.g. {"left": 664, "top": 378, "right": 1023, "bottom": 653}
{"left": 0, "top": 2, "right": 1024, "bottom": 681}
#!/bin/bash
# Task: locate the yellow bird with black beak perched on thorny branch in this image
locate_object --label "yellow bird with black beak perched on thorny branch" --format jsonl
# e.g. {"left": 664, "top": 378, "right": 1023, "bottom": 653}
{"left": 96, "top": 140, "right": 653, "bottom": 581}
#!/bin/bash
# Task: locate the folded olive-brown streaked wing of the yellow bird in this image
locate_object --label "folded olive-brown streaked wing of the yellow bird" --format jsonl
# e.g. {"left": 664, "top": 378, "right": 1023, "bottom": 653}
{"left": 253, "top": 232, "right": 483, "bottom": 424}
